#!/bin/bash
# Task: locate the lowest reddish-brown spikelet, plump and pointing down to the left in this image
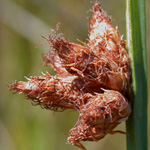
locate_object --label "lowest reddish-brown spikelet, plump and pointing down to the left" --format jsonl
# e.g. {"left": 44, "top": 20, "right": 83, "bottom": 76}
{"left": 68, "top": 90, "right": 131, "bottom": 145}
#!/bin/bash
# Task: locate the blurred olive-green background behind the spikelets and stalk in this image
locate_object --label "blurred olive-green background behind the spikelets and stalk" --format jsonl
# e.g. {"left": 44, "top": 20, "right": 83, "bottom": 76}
{"left": 0, "top": 0, "right": 150, "bottom": 150}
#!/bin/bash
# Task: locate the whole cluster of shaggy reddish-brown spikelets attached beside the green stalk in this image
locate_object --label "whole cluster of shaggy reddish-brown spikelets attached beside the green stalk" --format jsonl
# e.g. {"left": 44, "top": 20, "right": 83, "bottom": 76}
{"left": 9, "top": 2, "right": 131, "bottom": 150}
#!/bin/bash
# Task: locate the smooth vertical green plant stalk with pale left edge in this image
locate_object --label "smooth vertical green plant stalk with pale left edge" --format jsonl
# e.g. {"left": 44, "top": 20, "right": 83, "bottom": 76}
{"left": 126, "top": 0, "right": 147, "bottom": 150}
